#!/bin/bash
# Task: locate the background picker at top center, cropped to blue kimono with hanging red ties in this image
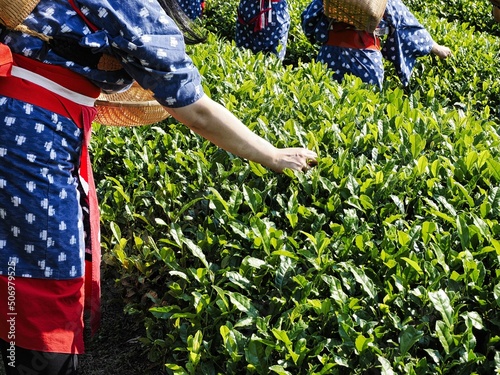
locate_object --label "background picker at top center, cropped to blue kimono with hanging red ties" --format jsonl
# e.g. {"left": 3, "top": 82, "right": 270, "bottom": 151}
{"left": 235, "top": 0, "right": 290, "bottom": 60}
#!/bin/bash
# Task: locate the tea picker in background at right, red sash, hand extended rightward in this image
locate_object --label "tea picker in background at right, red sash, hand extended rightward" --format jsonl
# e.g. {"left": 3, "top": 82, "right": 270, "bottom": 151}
{"left": 301, "top": 0, "right": 451, "bottom": 88}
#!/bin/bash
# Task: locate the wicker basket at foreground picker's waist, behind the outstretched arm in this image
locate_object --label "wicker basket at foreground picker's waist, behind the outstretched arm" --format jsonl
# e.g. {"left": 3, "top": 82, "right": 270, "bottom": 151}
{"left": 94, "top": 82, "right": 169, "bottom": 126}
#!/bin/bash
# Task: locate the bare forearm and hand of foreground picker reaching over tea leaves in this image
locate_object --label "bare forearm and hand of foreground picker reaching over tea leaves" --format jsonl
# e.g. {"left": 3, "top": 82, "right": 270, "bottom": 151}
{"left": 167, "top": 95, "right": 317, "bottom": 172}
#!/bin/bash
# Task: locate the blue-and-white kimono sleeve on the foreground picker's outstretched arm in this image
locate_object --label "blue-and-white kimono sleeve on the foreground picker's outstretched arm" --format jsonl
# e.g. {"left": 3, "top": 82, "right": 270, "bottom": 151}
{"left": 80, "top": 0, "right": 203, "bottom": 108}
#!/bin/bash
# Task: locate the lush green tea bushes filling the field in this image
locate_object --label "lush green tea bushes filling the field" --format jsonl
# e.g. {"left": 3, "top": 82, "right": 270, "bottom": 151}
{"left": 92, "top": 0, "right": 500, "bottom": 375}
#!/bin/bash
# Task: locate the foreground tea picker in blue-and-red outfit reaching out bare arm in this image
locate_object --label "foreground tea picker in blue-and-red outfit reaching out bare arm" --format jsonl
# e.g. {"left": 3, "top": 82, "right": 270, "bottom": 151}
{"left": 0, "top": 0, "right": 316, "bottom": 375}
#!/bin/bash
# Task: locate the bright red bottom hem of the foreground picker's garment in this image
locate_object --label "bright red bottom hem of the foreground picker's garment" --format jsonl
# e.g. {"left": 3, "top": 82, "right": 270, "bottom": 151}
{"left": 0, "top": 269, "right": 84, "bottom": 354}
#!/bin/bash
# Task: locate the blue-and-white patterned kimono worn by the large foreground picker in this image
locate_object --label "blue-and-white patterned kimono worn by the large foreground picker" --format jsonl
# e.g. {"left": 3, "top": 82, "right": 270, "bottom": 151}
{"left": 0, "top": 0, "right": 203, "bottom": 279}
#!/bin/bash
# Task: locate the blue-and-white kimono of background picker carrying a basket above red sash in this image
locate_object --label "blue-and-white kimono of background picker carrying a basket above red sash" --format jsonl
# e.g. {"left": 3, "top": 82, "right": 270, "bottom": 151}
{"left": 301, "top": 0, "right": 434, "bottom": 87}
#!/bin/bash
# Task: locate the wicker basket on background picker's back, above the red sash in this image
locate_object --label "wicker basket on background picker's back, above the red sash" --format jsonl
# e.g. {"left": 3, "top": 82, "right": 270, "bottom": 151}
{"left": 323, "top": 0, "right": 387, "bottom": 33}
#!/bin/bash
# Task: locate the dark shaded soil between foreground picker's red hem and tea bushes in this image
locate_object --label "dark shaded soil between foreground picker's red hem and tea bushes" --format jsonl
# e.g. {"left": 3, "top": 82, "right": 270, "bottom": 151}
{"left": 0, "top": 279, "right": 166, "bottom": 375}
